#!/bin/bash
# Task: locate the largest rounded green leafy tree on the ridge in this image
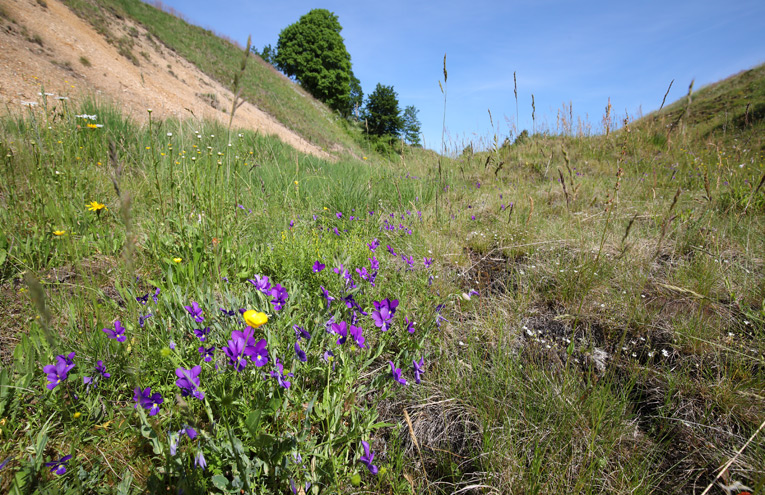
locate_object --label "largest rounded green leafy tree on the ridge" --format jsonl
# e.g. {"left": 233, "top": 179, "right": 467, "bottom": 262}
{"left": 274, "top": 9, "right": 360, "bottom": 116}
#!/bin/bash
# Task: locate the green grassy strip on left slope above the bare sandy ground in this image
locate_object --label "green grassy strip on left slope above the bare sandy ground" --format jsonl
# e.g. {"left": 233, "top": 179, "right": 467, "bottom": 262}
{"left": 64, "top": 0, "right": 363, "bottom": 155}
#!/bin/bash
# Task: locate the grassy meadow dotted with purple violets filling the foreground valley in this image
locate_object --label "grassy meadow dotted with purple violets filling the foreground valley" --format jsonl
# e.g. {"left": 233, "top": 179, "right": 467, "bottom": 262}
{"left": 0, "top": 45, "right": 765, "bottom": 494}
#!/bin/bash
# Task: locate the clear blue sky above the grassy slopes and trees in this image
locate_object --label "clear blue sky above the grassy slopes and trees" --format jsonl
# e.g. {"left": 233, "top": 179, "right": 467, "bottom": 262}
{"left": 151, "top": 0, "right": 765, "bottom": 150}
